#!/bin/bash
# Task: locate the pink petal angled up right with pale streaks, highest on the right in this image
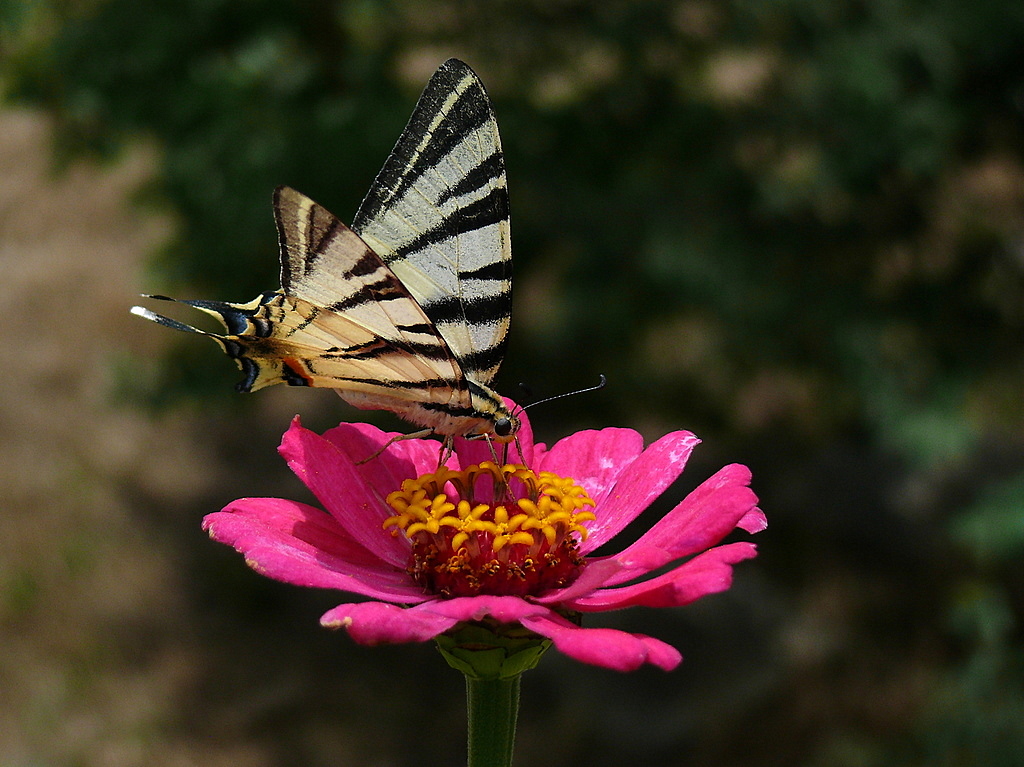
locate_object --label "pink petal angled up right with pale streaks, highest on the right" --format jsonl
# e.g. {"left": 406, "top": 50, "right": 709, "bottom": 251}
{"left": 573, "top": 431, "right": 700, "bottom": 554}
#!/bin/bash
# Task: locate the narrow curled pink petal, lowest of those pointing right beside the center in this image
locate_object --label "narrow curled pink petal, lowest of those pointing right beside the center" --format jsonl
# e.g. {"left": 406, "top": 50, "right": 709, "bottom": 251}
{"left": 565, "top": 541, "right": 757, "bottom": 612}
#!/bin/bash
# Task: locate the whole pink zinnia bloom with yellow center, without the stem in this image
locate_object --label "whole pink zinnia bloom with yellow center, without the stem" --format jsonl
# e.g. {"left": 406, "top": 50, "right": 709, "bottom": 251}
{"left": 203, "top": 407, "right": 767, "bottom": 671}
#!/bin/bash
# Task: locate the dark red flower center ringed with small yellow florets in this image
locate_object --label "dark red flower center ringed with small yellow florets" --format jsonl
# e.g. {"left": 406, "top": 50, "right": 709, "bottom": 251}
{"left": 384, "top": 461, "right": 596, "bottom": 597}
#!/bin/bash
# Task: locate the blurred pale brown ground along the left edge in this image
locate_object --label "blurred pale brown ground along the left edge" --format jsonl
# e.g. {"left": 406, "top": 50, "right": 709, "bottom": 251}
{"left": 0, "top": 110, "right": 246, "bottom": 767}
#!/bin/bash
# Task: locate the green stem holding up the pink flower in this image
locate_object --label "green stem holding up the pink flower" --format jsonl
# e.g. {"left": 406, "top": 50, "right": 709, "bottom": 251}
{"left": 466, "top": 674, "right": 520, "bottom": 767}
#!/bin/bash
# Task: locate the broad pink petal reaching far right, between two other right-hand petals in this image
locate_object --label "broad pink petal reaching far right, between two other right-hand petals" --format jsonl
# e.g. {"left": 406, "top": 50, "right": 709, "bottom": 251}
{"left": 609, "top": 464, "right": 758, "bottom": 584}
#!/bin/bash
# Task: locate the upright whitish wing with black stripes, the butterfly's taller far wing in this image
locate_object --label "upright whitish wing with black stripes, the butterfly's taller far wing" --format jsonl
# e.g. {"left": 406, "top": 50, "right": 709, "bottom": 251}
{"left": 352, "top": 59, "right": 511, "bottom": 384}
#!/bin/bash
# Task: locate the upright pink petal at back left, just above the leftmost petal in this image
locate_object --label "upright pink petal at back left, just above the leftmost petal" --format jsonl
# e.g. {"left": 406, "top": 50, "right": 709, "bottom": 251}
{"left": 279, "top": 418, "right": 415, "bottom": 568}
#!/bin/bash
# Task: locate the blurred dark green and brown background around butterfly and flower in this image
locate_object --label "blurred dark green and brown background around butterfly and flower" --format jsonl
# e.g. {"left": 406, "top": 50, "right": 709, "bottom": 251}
{"left": 0, "top": 0, "right": 1024, "bottom": 767}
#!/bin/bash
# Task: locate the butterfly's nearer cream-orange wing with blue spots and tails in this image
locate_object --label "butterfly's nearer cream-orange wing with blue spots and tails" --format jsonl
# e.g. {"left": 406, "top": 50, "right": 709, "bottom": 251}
{"left": 136, "top": 187, "right": 465, "bottom": 400}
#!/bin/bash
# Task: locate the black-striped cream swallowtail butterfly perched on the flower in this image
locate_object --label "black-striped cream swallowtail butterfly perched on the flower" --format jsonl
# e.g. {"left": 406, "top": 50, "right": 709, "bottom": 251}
{"left": 132, "top": 58, "right": 519, "bottom": 445}
